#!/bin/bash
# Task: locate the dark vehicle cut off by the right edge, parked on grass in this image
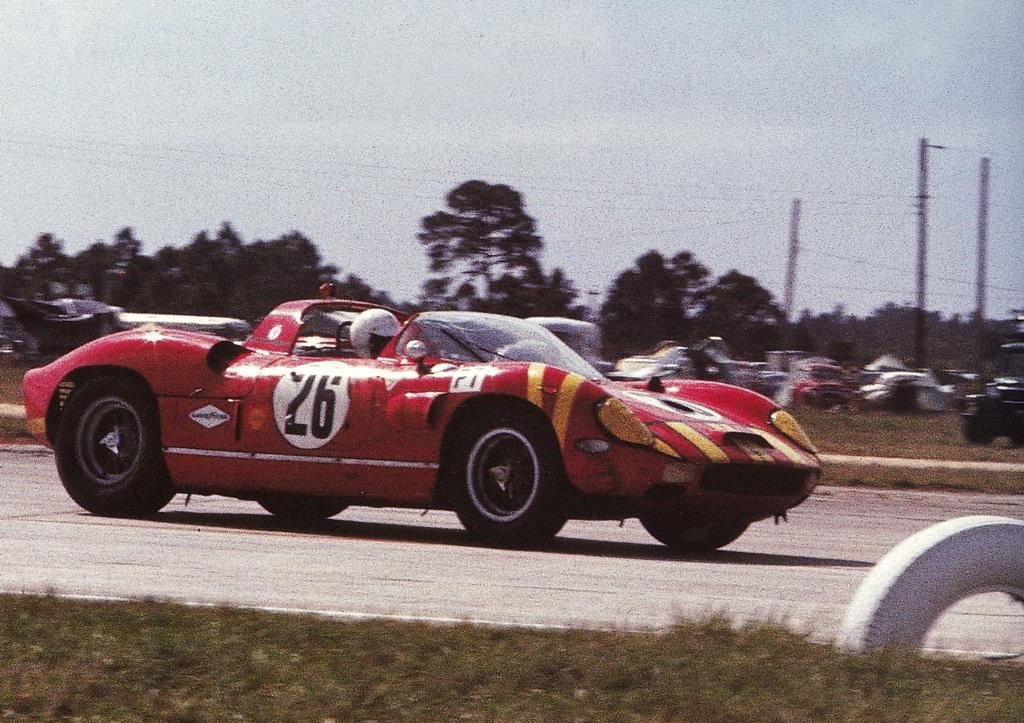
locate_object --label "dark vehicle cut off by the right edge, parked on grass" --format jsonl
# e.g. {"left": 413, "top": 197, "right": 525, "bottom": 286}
{"left": 962, "top": 317, "right": 1024, "bottom": 444}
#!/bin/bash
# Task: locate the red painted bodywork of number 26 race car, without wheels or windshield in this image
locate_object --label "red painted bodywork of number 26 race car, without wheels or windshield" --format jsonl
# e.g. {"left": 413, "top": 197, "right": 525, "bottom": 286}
{"left": 25, "top": 300, "right": 819, "bottom": 521}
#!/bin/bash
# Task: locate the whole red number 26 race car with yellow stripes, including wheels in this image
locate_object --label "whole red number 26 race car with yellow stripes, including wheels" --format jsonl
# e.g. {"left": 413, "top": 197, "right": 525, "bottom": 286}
{"left": 25, "top": 299, "right": 820, "bottom": 551}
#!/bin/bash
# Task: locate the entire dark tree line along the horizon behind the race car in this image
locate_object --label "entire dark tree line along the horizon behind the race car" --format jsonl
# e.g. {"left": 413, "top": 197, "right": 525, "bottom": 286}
{"left": 0, "top": 180, "right": 997, "bottom": 367}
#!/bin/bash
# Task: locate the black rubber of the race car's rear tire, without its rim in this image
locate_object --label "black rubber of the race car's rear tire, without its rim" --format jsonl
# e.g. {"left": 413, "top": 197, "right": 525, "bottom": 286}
{"left": 54, "top": 376, "right": 175, "bottom": 517}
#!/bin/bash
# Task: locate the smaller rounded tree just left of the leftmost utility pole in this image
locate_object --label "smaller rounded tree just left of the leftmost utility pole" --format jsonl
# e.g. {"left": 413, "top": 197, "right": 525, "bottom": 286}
{"left": 699, "top": 269, "right": 785, "bottom": 359}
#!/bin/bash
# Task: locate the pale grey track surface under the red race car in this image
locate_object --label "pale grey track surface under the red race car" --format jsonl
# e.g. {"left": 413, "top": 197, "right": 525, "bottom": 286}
{"left": 0, "top": 446, "right": 1024, "bottom": 654}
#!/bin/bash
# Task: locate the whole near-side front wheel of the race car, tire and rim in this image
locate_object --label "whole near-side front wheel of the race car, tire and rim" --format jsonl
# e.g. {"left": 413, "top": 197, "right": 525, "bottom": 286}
{"left": 449, "top": 410, "right": 568, "bottom": 547}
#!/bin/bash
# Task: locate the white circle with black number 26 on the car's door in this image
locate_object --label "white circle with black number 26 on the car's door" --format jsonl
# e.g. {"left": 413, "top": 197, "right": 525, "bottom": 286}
{"left": 273, "top": 365, "right": 348, "bottom": 450}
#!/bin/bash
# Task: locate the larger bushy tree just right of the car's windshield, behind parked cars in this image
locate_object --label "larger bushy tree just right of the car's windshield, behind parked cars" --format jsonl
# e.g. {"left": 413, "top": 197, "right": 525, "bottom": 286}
{"left": 601, "top": 251, "right": 710, "bottom": 356}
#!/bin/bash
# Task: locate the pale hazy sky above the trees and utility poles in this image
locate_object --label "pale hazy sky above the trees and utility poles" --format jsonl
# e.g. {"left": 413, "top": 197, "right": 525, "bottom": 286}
{"left": 0, "top": 0, "right": 1024, "bottom": 317}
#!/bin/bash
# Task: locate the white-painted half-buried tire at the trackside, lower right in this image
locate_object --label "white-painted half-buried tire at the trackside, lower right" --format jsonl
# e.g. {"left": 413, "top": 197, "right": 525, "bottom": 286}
{"left": 840, "top": 515, "right": 1024, "bottom": 650}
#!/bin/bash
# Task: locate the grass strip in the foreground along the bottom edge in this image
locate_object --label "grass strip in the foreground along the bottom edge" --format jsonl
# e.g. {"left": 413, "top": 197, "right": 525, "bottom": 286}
{"left": 0, "top": 596, "right": 1024, "bottom": 722}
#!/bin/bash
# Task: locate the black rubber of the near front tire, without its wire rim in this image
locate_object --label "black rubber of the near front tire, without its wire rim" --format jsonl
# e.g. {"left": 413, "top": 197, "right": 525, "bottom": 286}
{"left": 445, "top": 408, "right": 569, "bottom": 547}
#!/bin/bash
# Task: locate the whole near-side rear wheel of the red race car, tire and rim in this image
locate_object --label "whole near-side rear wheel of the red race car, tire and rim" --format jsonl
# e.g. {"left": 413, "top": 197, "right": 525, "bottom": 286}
{"left": 54, "top": 377, "right": 174, "bottom": 517}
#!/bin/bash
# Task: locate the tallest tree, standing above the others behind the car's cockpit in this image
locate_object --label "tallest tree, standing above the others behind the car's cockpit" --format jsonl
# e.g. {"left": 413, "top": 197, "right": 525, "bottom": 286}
{"left": 417, "top": 180, "right": 544, "bottom": 308}
